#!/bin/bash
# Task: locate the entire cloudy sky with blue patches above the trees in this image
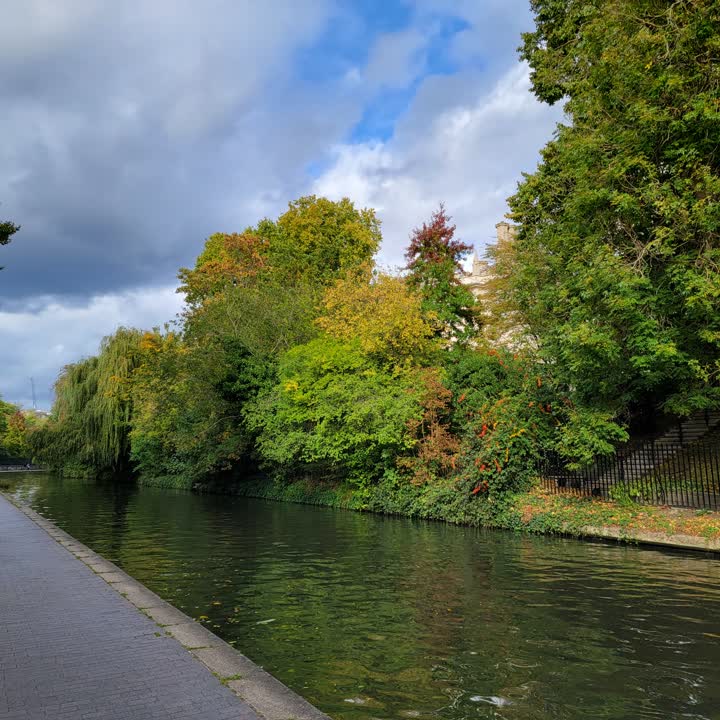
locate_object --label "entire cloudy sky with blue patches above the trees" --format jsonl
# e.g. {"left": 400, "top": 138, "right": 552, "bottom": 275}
{"left": 0, "top": 0, "right": 562, "bottom": 409}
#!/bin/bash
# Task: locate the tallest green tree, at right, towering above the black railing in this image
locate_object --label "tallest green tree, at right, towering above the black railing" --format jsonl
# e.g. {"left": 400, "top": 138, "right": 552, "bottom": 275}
{"left": 510, "top": 0, "right": 720, "bottom": 451}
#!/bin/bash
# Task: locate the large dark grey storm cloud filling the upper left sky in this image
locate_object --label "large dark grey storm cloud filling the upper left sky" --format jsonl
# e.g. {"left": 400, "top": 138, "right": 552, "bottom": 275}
{"left": 0, "top": 0, "right": 342, "bottom": 306}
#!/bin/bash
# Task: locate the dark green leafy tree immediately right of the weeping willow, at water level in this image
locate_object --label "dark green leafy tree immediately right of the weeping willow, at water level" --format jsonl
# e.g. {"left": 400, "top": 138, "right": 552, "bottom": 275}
{"left": 130, "top": 332, "right": 274, "bottom": 487}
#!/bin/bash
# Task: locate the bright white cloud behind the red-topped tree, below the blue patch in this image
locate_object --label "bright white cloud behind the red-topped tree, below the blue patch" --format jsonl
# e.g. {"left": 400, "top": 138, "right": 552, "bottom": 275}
{"left": 314, "top": 64, "right": 561, "bottom": 264}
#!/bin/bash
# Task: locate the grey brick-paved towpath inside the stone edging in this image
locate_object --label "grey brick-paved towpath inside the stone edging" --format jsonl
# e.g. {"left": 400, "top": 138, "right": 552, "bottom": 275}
{"left": 0, "top": 497, "right": 258, "bottom": 720}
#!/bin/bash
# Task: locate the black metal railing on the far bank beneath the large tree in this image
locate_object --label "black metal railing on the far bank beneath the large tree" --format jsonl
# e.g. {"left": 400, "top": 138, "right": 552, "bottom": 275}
{"left": 539, "top": 438, "right": 720, "bottom": 510}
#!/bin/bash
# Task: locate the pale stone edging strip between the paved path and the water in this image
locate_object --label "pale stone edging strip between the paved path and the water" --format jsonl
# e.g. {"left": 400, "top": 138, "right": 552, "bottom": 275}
{"left": 0, "top": 493, "right": 331, "bottom": 720}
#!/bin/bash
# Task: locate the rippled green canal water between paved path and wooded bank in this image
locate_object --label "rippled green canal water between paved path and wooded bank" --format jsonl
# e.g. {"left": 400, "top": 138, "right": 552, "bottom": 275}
{"left": 0, "top": 474, "right": 720, "bottom": 720}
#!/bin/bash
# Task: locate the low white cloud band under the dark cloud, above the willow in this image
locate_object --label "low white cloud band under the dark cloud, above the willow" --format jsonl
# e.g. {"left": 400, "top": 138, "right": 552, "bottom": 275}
{"left": 0, "top": 287, "right": 182, "bottom": 409}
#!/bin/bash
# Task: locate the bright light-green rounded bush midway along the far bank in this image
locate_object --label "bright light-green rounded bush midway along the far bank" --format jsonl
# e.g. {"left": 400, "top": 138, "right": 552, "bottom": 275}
{"left": 247, "top": 337, "right": 419, "bottom": 486}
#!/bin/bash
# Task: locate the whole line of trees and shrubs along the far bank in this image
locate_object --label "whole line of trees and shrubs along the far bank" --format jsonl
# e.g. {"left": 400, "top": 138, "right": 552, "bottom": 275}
{"left": 30, "top": 0, "right": 720, "bottom": 524}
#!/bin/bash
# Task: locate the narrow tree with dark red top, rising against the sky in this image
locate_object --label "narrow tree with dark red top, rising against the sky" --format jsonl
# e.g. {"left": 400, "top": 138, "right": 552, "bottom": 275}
{"left": 405, "top": 205, "right": 479, "bottom": 341}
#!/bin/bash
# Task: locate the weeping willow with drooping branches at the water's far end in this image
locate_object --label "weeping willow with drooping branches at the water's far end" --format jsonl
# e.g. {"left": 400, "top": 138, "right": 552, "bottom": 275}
{"left": 32, "top": 328, "right": 143, "bottom": 475}
